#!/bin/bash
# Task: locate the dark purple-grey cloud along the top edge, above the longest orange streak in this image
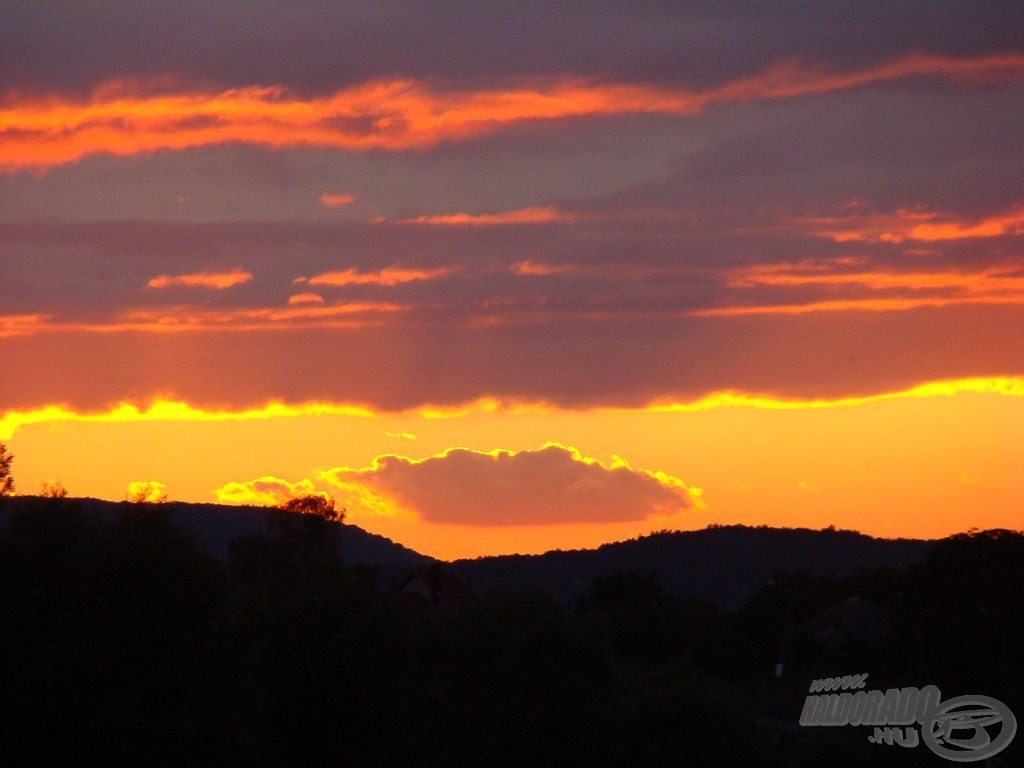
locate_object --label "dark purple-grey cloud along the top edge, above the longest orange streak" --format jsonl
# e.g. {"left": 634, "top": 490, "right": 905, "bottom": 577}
{"left": 0, "top": 0, "right": 1024, "bottom": 92}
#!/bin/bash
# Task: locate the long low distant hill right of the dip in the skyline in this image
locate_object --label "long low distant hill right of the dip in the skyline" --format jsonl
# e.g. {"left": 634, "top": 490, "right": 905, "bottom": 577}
{"left": 453, "top": 525, "right": 933, "bottom": 609}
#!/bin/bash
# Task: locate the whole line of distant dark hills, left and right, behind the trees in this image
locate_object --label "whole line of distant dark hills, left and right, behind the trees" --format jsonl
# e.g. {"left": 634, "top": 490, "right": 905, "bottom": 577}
{"left": 0, "top": 497, "right": 933, "bottom": 609}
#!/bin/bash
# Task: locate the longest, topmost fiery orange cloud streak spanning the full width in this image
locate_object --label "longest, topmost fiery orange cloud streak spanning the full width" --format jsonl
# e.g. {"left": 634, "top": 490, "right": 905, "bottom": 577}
{"left": 0, "top": 53, "right": 1024, "bottom": 172}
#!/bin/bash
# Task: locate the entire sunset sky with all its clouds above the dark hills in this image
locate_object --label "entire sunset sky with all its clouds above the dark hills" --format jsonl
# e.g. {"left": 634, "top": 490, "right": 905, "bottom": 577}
{"left": 0, "top": 0, "right": 1024, "bottom": 558}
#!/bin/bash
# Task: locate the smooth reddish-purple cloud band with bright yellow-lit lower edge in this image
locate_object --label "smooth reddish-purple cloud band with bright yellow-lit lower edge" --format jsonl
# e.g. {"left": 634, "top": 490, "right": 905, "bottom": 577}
{"left": 0, "top": 306, "right": 1024, "bottom": 410}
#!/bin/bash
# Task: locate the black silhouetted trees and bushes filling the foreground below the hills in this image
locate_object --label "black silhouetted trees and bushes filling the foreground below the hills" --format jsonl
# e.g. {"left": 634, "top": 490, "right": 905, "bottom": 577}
{"left": 0, "top": 499, "right": 1024, "bottom": 768}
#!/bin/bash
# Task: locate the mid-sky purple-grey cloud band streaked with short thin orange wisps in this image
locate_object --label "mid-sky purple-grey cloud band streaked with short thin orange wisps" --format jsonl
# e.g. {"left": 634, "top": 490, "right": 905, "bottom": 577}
{"left": 0, "top": 199, "right": 1024, "bottom": 325}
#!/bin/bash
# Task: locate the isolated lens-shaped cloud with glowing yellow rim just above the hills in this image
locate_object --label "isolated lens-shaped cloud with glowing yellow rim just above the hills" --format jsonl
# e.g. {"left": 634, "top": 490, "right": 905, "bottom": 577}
{"left": 322, "top": 443, "right": 700, "bottom": 526}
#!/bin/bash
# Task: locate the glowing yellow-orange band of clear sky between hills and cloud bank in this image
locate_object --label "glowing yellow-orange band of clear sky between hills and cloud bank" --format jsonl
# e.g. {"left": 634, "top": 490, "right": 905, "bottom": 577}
{"left": 0, "top": 378, "right": 1024, "bottom": 557}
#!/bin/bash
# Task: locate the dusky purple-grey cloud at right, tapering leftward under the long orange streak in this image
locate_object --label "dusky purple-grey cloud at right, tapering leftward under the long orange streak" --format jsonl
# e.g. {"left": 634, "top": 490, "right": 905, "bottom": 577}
{"left": 580, "top": 87, "right": 1024, "bottom": 219}
